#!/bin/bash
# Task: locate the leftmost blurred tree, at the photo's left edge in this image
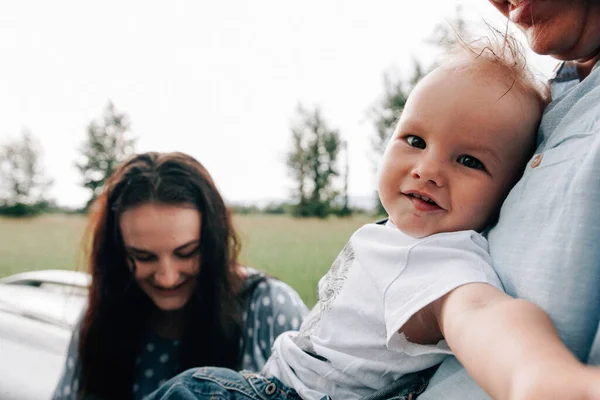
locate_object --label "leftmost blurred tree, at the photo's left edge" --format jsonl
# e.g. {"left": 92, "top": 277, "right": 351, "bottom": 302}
{"left": 0, "top": 129, "right": 52, "bottom": 216}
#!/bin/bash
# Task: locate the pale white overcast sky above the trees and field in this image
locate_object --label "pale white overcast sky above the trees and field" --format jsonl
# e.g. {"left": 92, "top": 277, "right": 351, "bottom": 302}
{"left": 0, "top": 0, "right": 554, "bottom": 206}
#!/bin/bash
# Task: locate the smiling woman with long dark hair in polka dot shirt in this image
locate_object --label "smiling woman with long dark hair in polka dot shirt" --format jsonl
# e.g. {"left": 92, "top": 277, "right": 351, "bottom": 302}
{"left": 54, "top": 153, "right": 307, "bottom": 399}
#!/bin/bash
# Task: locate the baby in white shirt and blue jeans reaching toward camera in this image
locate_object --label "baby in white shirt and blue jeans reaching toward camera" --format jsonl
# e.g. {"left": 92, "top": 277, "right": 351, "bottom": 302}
{"left": 145, "top": 35, "right": 600, "bottom": 400}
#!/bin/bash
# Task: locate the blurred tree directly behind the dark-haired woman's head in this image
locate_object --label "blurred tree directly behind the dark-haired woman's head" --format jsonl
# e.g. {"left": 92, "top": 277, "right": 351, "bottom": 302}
{"left": 76, "top": 101, "right": 136, "bottom": 208}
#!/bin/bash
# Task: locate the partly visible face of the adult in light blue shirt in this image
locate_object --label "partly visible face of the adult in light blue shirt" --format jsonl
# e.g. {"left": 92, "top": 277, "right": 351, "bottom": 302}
{"left": 489, "top": 0, "right": 600, "bottom": 62}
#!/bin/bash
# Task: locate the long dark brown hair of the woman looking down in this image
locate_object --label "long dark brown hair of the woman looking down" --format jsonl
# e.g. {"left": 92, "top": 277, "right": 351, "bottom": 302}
{"left": 78, "top": 153, "right": 242, "bottom": 399}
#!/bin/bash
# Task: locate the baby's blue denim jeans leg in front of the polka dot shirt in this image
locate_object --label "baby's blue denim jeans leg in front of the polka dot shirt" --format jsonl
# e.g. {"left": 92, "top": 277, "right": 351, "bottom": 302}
{"left": 144, "top": 367, "right": 300, "bottom": 400}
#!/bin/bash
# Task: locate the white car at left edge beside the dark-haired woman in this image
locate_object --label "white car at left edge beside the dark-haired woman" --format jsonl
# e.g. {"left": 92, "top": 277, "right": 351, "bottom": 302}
{"left": 0, "top": 270, "right": 91, "bottom": 400}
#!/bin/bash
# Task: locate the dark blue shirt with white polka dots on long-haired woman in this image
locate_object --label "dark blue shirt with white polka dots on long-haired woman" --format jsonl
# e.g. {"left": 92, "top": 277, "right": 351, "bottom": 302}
{"left": 53, "top": 268, "right": 308, "bottom": 400}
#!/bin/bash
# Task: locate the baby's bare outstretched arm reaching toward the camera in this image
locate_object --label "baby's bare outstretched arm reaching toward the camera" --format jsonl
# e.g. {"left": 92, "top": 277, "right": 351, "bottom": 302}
{"left": 430, "top": 283, "right": 600, "bottom": 399}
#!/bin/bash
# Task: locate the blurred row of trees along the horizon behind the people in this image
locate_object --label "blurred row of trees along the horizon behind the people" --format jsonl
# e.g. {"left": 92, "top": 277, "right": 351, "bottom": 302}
{"left": 0, "top": 8, "right": 465, "bottom": 218}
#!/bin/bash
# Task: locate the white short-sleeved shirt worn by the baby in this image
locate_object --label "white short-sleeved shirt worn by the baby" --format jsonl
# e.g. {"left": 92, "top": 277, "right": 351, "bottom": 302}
{"left": 263, "top": 224, "right": 502, "bottom": 400}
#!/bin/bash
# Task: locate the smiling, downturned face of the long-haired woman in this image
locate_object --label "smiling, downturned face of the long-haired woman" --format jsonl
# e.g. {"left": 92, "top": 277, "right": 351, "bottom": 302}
{"left": 119, "top": 203, "right": 202, "bottom": 311}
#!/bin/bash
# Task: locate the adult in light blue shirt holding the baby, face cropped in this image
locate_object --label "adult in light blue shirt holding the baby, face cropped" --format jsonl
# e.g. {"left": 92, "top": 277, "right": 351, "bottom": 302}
{"left": 419, "top": 0, "right": 600, "bottom": 400}
